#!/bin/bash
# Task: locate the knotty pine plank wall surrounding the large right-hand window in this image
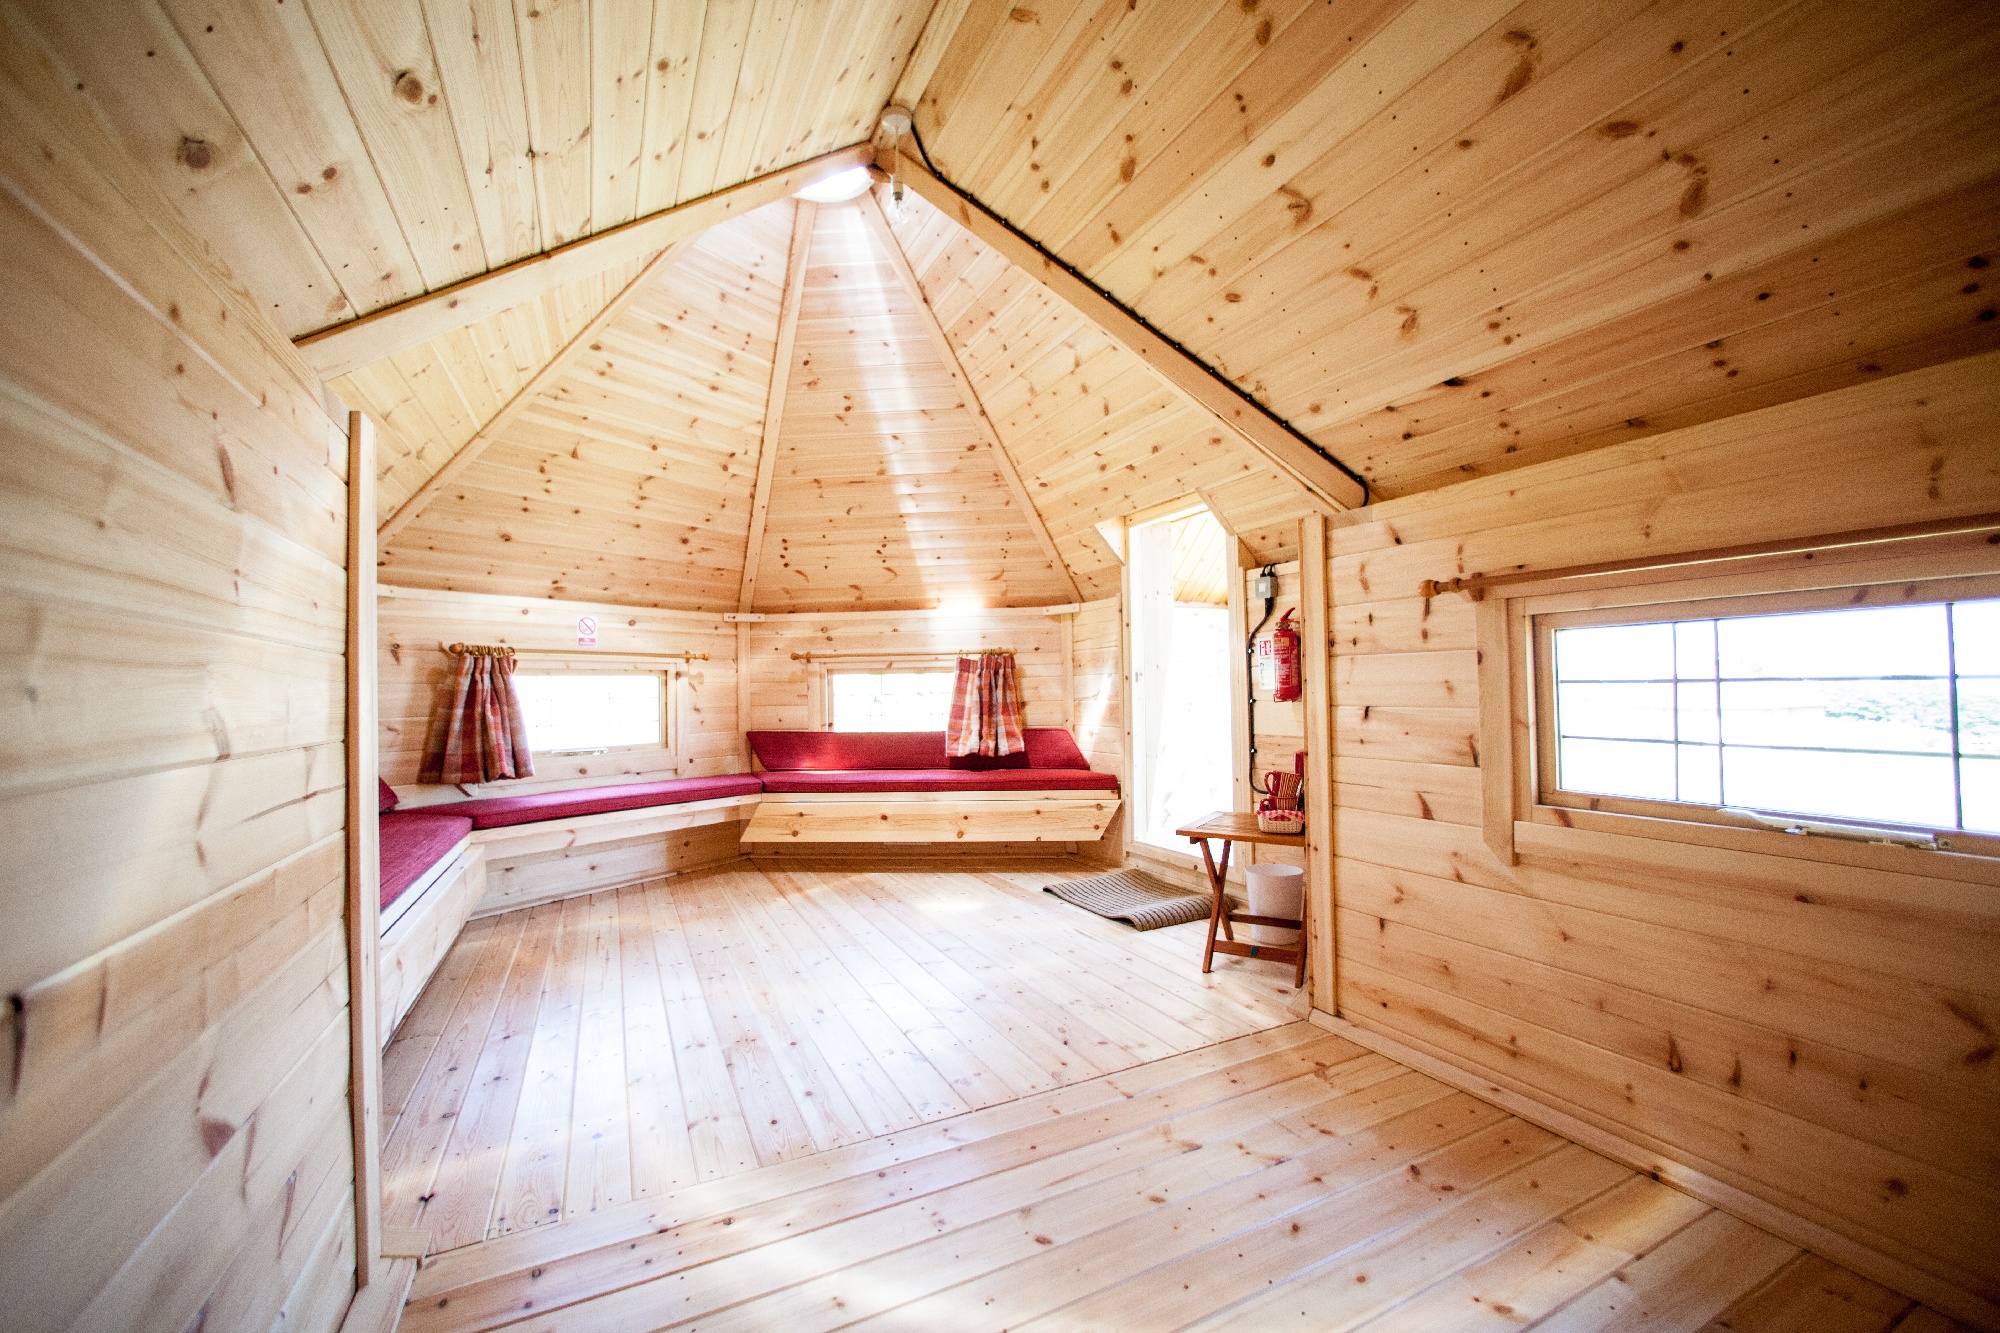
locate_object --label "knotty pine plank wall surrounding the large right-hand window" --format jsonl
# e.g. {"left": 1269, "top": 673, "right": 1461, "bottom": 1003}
{"left": 1330, "top": 354, "right": 2000, "bottom": 1311}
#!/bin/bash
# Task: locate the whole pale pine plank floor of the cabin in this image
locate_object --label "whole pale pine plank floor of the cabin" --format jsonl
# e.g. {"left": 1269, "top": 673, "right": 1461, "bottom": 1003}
{"left": 386, "top": 865, "right": 1958, "bottom": 1333}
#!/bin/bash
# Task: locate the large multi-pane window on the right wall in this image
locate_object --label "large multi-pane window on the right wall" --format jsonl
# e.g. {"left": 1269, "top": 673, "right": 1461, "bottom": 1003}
{"left": 1532, "top": 584, "right": 2000, "bottom": 851}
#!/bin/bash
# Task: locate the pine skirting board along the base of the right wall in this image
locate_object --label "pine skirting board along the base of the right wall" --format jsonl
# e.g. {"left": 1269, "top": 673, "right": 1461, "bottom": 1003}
{"left": 1312, "top": 1009, "right": 2000, "bottom": 1333}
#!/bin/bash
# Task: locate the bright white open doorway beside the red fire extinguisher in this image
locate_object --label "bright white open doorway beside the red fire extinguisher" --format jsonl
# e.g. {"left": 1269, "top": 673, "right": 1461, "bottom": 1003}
{"left": 1128, "top": 504, "right": 1234, "bottom": 851}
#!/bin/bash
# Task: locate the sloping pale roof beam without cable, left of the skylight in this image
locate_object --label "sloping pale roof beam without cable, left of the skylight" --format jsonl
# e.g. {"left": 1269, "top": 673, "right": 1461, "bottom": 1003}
{"left": 296, "top": 144, "right": 870, "bottom": 378}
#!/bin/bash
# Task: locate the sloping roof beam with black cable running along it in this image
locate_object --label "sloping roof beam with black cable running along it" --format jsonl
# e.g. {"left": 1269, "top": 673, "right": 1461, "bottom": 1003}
{"left": 900, "top": 152, "right": 1368, "bottom": 508}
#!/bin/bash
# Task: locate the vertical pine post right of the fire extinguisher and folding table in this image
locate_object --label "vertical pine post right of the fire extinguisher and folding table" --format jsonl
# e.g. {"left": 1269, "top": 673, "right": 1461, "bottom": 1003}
{"left": 1298, "top": 514, "right": 1340, "bottom": 1013}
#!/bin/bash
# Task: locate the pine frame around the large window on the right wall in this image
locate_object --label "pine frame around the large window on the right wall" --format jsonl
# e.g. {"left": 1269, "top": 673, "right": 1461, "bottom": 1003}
{"left": 1468, "top": 532, "right": 2000, "bottom": 887}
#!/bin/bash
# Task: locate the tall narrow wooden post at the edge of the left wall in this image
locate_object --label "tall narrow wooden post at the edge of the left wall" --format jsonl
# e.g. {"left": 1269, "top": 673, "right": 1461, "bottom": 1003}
{"left": 346, "top": 412, "right": 382, "bottom": 1287}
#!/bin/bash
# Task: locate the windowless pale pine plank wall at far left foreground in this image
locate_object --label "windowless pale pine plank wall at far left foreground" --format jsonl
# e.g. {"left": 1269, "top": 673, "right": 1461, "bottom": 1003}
{"left": 0, "top": 20, "right": 354, "bottom": 1333}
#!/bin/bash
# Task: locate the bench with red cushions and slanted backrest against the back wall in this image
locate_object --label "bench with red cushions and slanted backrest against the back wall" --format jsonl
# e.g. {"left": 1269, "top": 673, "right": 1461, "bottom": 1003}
{"left": 742, "top": 727, "right": 1118, "bottom": 847}
